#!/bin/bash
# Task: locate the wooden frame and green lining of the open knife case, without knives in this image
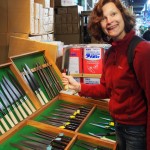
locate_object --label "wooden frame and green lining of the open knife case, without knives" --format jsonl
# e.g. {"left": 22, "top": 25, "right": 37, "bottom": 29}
{"left": 0, "top": 50, "right": 116, "bottom": 150}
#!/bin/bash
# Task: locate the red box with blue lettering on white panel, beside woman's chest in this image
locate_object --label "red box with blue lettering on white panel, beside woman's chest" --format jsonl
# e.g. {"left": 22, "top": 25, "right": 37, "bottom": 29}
{"left": 83, "top": 47, "right": 104, "bottom": 74}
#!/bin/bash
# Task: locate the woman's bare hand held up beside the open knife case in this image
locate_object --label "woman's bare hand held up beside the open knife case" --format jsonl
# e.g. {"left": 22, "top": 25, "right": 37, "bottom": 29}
{"left": 62, "top": 73, "right": 81, "bottom": 92}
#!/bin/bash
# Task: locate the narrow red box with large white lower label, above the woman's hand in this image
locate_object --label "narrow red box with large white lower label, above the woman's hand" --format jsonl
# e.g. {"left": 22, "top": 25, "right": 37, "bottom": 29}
{"left": 69, "top": 46, "right": 83, "bottom": 74}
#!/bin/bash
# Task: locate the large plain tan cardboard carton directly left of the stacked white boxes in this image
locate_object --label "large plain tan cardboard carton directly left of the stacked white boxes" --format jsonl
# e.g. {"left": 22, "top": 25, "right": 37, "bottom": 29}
{"left": 8, "top": 0, "right": 34, "bottom": 33}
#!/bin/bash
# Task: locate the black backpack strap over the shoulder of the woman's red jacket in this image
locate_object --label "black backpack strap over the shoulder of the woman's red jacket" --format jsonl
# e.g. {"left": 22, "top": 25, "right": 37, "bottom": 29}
{"left": 127, "top": 35, "right": 144, "bottom": 72}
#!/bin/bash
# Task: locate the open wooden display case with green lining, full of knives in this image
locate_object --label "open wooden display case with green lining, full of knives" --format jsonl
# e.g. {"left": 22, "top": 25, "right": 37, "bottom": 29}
{"left": 0, "top": 50, "right": 116, "bottom": 150}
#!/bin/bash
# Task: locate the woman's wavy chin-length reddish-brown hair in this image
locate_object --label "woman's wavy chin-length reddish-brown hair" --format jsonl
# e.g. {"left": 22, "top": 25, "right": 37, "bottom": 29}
{"left": 88, "top": 0, "right": 135, "bottom": 42}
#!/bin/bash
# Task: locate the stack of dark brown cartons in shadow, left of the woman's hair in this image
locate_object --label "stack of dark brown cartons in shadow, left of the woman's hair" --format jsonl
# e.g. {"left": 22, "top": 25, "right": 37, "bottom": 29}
{"left": 55, "top": 5, "right": 83, "bottom": 44}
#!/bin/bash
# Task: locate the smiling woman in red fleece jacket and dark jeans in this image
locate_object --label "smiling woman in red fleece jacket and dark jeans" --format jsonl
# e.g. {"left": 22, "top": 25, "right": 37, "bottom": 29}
{"left": 62, "top": 0, "right": 150, "bottom": 150}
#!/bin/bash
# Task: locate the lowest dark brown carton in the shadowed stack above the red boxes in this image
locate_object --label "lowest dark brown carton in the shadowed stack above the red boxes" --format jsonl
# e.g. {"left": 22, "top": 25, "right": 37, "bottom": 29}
{"left": 55, "top": 34, "right": 80, "bottom": 45}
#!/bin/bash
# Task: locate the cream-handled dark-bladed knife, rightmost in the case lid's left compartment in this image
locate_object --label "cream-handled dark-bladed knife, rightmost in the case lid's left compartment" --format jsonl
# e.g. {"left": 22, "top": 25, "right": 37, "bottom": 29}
{"left": 7, "top": 72, "right": 36, "bottom": 112}
